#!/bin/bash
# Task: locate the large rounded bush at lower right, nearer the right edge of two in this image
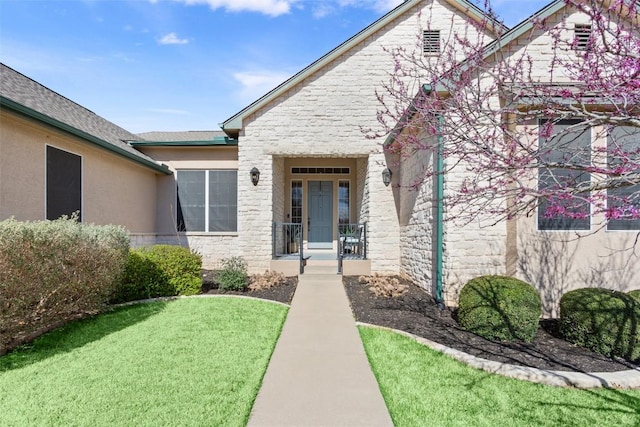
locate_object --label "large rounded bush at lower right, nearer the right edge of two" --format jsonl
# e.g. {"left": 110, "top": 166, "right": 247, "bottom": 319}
{"left": 560, "top": 288, "right": 640, "bottom": 360}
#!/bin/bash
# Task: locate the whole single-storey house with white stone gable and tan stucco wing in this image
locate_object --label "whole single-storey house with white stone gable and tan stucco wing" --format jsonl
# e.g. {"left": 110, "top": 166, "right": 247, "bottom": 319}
{"left": 0, "top": 0, "right": 638, "bottom": 313}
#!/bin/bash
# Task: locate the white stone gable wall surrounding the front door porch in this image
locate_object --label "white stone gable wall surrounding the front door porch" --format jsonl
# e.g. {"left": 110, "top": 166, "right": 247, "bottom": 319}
{"left": 238, "top": 2, "right": 490, "bottom": 273}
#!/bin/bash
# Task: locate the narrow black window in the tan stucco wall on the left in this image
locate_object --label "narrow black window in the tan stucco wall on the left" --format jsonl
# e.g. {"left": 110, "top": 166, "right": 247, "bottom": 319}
{"left": 46, "top": 145, "right": 82, "bottom": 221}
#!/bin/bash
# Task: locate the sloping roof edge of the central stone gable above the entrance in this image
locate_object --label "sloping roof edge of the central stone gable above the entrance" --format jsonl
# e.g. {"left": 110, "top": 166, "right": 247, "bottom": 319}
{"left": 220, "top": 0, "right": 507, "bottom": 135}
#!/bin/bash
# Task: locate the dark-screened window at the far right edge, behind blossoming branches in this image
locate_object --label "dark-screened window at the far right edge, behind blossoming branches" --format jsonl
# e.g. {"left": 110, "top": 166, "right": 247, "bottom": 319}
{"left": 607, "top": 127, "right": 640, "bottom": 230}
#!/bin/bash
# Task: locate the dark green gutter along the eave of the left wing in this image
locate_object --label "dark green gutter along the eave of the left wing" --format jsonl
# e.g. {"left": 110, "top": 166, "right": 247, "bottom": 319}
{"left": 0, "top": 96, "right": 172, "bottom": 175}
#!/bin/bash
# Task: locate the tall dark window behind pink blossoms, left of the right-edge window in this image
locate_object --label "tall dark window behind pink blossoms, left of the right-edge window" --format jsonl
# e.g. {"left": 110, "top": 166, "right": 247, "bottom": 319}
{"left": 538, "top": 120, "right": 591, "bottom": 230}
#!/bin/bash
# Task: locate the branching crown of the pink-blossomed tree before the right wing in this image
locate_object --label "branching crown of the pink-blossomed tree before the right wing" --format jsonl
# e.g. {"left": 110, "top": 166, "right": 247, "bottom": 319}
{"left": 367, "top": 0, "right": 640, "bottom": 230}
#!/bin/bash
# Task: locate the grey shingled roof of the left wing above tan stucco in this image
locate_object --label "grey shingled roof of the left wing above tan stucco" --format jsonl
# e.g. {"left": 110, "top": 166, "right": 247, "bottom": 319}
{"left": 0, "top": 63, "right": 171, "bottom": 175}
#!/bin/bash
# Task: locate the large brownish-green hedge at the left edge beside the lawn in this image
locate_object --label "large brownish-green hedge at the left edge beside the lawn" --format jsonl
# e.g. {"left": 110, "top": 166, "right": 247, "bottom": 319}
{"left": 0, "top": 217, "right": 129, "bottom": 354}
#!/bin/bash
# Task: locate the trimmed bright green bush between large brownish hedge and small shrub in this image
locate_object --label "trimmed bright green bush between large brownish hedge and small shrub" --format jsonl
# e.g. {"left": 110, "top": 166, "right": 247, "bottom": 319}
{"left": 111, "top": 245, "right": 202, "bottom": 303}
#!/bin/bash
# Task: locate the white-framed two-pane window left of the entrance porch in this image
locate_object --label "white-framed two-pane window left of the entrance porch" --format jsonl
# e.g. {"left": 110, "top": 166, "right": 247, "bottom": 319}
{"left": 176, "top": 170, "right": 238, "bottom": 232}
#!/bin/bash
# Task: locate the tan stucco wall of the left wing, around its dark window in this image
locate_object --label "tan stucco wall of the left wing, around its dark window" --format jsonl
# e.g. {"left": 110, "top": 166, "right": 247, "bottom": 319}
{"left": 0, "top": 111, "right": 156, "bottom": 233}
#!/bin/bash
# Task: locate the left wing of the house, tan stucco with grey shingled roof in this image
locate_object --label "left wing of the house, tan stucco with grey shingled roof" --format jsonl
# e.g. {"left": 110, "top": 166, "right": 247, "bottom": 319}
{"left": 0, "top": 65, "right": 171, "bottom": 233}
